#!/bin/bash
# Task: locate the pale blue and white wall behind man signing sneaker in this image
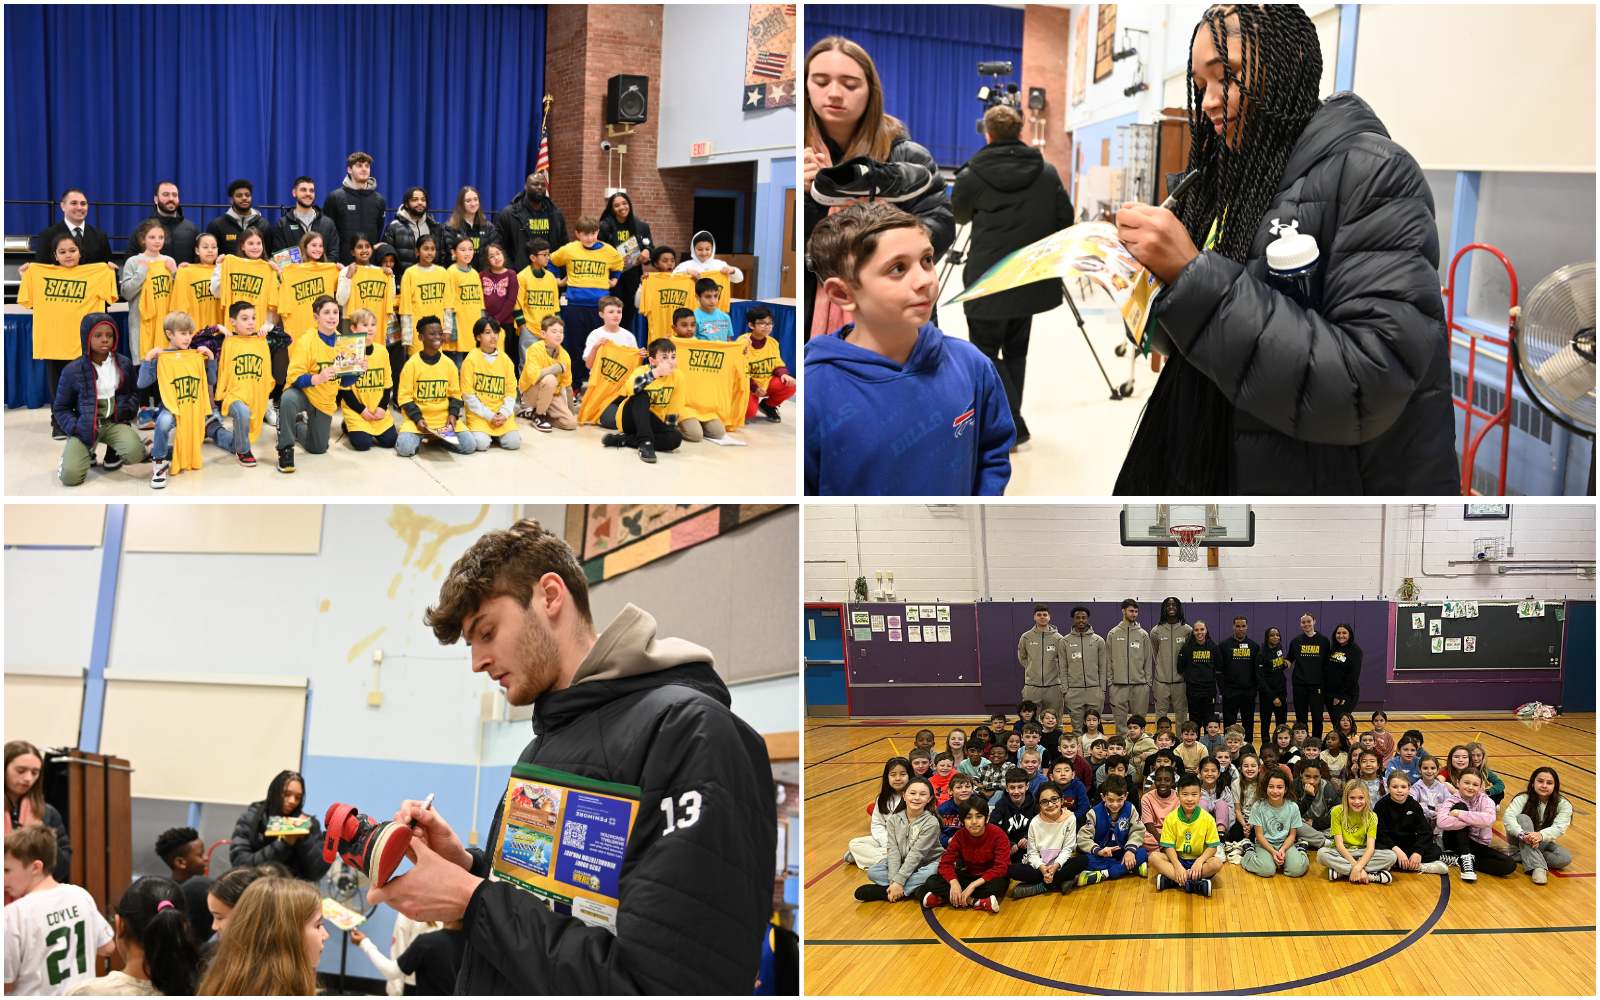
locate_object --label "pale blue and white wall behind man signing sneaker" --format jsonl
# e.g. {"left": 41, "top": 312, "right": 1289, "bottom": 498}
{"left": 5, "top": 504, "right": 798, "bottom": 978}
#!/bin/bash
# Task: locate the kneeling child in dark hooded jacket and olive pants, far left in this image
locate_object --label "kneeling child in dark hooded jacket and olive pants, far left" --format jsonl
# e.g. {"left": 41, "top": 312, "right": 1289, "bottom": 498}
{"left": 51, "top": 312, "right": 146, "bottom": 486}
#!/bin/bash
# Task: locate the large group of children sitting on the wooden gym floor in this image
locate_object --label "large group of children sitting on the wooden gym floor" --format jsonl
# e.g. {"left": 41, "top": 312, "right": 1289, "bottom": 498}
{"left": 845, "top": 701, "right": 1571, "bottom": 912}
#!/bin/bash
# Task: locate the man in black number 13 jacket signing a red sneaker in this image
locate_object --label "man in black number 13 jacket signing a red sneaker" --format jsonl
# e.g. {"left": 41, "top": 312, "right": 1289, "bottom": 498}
{"left": 368, "top": 520, "right": 778, "bottom": 995}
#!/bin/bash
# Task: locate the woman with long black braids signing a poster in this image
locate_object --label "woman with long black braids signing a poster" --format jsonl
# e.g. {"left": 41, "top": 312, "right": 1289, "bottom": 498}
{"left": 1115, "top": 3, "right": 1461, "bottom": 494}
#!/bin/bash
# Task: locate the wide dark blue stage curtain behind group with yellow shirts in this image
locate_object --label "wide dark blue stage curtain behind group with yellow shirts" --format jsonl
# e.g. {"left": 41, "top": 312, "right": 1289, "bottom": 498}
{"left": 5, "top": 3, "right": 547, "bottom": 241}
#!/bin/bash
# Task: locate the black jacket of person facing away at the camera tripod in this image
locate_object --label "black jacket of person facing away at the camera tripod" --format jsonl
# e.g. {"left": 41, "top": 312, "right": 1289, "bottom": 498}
{"left": 950, "top": 139, "right": 1072, "bottom": 320}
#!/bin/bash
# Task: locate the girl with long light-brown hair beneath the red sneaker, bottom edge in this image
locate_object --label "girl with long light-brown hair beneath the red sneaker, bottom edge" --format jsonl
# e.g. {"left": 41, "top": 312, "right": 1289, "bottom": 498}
{"left": 197, "top": 878, "right": 328, "bottom": 997}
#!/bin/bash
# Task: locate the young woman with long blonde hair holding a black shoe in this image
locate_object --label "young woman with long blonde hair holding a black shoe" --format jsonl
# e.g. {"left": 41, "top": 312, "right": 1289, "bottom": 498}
{"left": 805, "top": 35, "right": 955, "bottom": 339}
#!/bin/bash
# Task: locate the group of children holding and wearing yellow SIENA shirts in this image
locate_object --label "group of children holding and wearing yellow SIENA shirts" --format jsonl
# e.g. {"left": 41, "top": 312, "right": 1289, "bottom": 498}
{"left": 31, "top": 216, "right": 795, "bottom": 490}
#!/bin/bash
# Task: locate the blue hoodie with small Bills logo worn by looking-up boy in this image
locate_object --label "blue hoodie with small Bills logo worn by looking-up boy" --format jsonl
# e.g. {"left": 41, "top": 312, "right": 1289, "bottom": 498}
{"left": 805, "top": 323, "right": 1016, "bottom": 496}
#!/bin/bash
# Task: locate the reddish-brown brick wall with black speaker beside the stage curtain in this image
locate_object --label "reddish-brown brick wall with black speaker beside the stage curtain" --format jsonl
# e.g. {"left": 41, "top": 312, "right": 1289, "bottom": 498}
{"left": 544, "top": 3, "right": 755, "bottom": 253}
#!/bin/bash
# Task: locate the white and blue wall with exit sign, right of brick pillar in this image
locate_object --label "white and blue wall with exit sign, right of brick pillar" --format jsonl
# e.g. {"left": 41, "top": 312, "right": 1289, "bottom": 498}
{"left": 656, "top": 3, "right": 800, "bottom": 299}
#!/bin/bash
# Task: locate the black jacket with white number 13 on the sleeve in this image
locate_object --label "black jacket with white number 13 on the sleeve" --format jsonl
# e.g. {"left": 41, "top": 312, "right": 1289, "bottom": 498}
{"left": 456, "top": 605, "right": 778, "bottom": 995}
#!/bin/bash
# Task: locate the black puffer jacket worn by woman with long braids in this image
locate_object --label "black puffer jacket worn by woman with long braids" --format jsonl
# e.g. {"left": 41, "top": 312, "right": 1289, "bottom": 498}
{"left": 1117, "top": 93, "right": 1461, "bottom": 496}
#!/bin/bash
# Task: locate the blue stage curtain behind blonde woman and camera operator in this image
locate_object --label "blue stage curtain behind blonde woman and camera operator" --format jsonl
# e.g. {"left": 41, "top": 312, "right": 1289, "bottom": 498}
{"left": 805, "top": 3, "right": 1027, "bottom": 166}
